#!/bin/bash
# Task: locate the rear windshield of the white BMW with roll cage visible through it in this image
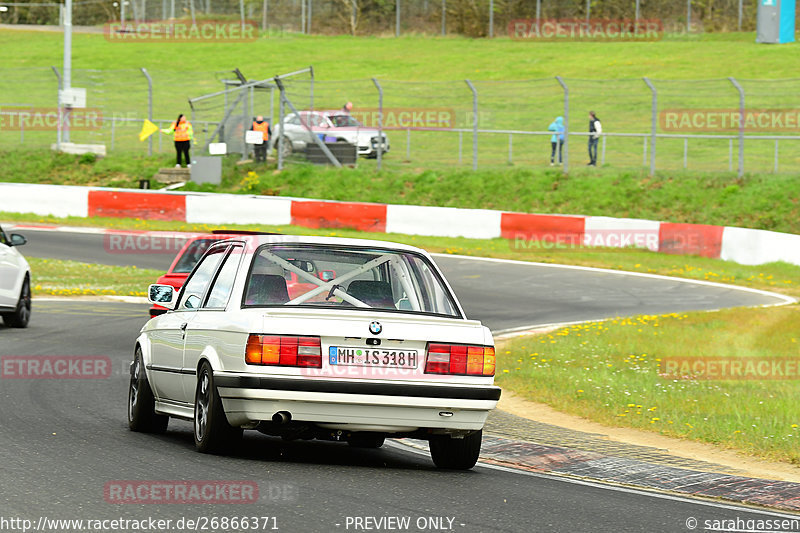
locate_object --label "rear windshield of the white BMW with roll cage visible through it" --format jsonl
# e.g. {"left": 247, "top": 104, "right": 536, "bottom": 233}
{"left": 242, "top": 245, "right": 462, "bottom": 318}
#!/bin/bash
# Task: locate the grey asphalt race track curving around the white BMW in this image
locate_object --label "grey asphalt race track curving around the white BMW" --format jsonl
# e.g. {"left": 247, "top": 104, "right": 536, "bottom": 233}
{"left": 0, "top": 227, "right": 796, "bottom": 532}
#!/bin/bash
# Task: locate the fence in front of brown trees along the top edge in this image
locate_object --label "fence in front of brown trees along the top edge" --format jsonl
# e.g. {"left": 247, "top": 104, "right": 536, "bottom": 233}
{"left": 0, "top": 0, "right": 776, "bottom": 37}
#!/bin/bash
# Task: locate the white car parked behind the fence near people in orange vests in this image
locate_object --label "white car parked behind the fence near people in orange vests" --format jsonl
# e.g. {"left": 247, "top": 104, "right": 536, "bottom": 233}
{"left": 275, "top": 111, "right": 389, "bottom": 158}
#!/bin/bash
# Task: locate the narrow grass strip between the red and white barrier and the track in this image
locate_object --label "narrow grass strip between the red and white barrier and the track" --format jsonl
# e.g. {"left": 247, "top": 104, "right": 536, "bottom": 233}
{"left": 6, "top": 211, "right": 800, "bottom": 297}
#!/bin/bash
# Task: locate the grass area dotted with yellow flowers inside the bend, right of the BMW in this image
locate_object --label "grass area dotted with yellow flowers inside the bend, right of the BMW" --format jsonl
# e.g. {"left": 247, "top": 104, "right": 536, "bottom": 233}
{"left": 497, "top": 305, "right": 800, "bottom": 465}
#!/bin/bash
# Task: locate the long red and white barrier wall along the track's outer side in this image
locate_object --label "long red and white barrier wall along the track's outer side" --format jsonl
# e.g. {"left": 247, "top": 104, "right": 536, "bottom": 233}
{"left": 0, "top": 183, "right": 800, "bottom": 265}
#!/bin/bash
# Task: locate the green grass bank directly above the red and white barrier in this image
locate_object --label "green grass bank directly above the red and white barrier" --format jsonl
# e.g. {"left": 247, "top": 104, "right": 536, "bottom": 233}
{"left": 0, "top": 150, "right": 800, "bottom": 233}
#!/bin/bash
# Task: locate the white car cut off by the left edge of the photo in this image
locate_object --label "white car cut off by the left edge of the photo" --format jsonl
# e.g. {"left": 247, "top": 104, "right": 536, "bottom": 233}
{"left": 0, "top": 228, "right": 31, "bottom": 328}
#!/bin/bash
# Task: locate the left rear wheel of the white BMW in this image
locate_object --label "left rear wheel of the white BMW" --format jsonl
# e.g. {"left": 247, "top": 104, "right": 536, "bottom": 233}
{"left": 192, "top": 361, "right": 242, "bottom": 453}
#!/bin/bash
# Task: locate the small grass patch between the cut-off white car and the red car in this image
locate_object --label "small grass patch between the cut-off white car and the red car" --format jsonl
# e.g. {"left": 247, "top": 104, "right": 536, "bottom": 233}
{"left": 27, "top": 257, "right": 163, "bottom": 296}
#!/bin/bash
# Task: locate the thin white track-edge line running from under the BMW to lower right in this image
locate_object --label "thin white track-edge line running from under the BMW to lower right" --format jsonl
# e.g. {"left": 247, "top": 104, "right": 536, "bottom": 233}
{"left": 386, "top": 440, "right": 798, "bottom": 520}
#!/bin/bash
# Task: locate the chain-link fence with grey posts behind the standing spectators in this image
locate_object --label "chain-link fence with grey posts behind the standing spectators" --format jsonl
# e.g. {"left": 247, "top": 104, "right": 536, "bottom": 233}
{"left": 0, "top": 68, "right": 800, "bottom": 173}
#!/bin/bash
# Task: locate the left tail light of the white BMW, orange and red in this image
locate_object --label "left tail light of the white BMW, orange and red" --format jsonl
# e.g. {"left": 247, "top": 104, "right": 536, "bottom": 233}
{"left": 244, "top": 334, "right": 322, "bottom": 368}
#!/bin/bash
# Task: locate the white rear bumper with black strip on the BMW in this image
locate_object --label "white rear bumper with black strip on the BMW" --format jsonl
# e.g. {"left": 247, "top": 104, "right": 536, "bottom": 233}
{"left": 214, "top": 373, "right": 500, "bottom": 433}
